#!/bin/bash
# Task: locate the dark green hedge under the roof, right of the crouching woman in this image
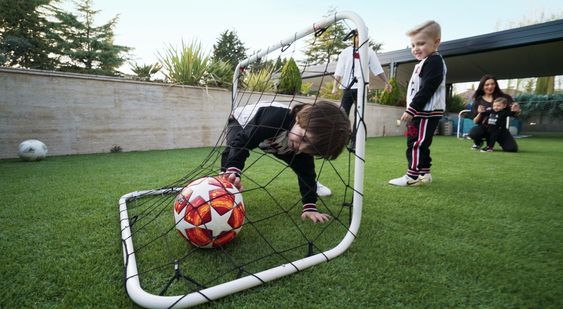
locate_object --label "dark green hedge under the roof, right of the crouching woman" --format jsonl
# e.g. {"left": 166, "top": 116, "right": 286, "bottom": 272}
{"left": 514, "top": 93, "right": 563, "bottom": 119}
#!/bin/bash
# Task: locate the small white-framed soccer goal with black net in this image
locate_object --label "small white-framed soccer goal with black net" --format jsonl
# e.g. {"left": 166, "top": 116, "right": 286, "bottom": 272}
{"left": 119, "top": 12, "right": 369, "bottom": 308}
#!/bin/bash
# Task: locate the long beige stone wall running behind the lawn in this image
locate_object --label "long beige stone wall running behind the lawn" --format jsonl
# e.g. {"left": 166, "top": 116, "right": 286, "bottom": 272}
{"left": 0, "top": 68, "right": 410, "bottom": 159}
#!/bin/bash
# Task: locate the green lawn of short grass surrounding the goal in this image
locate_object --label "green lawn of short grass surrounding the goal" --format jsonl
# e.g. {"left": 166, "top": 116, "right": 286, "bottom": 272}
{"left": 0, "top": 134, "right": 563, "bottom": 308}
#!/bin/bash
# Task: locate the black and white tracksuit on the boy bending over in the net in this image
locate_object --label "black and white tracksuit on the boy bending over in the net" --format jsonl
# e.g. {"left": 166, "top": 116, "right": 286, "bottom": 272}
{"left": 221, "top": 104, "right": 317, "bottom": 212}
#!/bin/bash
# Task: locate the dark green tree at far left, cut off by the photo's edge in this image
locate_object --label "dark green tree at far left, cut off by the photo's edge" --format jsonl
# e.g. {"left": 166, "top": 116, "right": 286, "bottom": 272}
{"left": 0, "top": 0, "right": 58, "bottom": 70}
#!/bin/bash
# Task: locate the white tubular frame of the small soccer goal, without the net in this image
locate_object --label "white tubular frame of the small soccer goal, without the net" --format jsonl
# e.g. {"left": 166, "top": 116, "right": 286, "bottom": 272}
{"left": 119, "top": 11, "right": 369, "bottom": 308}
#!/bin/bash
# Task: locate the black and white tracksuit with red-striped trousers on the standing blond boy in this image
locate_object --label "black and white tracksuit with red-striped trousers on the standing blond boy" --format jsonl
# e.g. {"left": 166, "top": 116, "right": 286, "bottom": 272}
{"left": 406, "top": 52, "right": 447, "bottom": 178}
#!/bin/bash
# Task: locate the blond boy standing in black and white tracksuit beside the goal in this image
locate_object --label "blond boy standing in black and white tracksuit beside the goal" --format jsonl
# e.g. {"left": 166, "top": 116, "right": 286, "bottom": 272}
{"left": 389, "top": 20, "right": 447, "bottom": 187}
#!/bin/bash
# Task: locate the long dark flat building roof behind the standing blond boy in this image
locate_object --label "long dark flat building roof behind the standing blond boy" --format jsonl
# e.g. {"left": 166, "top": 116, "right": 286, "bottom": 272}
{"left": 303, "top": 19, "right": 563, "bottom": 89}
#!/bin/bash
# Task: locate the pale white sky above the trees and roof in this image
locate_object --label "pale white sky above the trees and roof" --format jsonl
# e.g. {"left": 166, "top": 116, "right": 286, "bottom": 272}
{"left": 63, "top": 0, "right": 563, "bottom": 86}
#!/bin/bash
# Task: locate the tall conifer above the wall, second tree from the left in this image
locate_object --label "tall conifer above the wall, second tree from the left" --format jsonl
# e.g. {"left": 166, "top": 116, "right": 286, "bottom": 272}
{"left": 56, "top": 0, "right": 131, "bottom": 75}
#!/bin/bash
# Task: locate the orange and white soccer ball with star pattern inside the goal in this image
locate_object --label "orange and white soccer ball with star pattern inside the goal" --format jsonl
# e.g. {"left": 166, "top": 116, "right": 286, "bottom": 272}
{"left": 174, "top": 177, "right": 245, "bottom": 248}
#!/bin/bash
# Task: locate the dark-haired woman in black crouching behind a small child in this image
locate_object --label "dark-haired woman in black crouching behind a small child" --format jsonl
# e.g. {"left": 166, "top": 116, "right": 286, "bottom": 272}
{"left": 469, "top": 74, "right": 520, "bottom": 152}
